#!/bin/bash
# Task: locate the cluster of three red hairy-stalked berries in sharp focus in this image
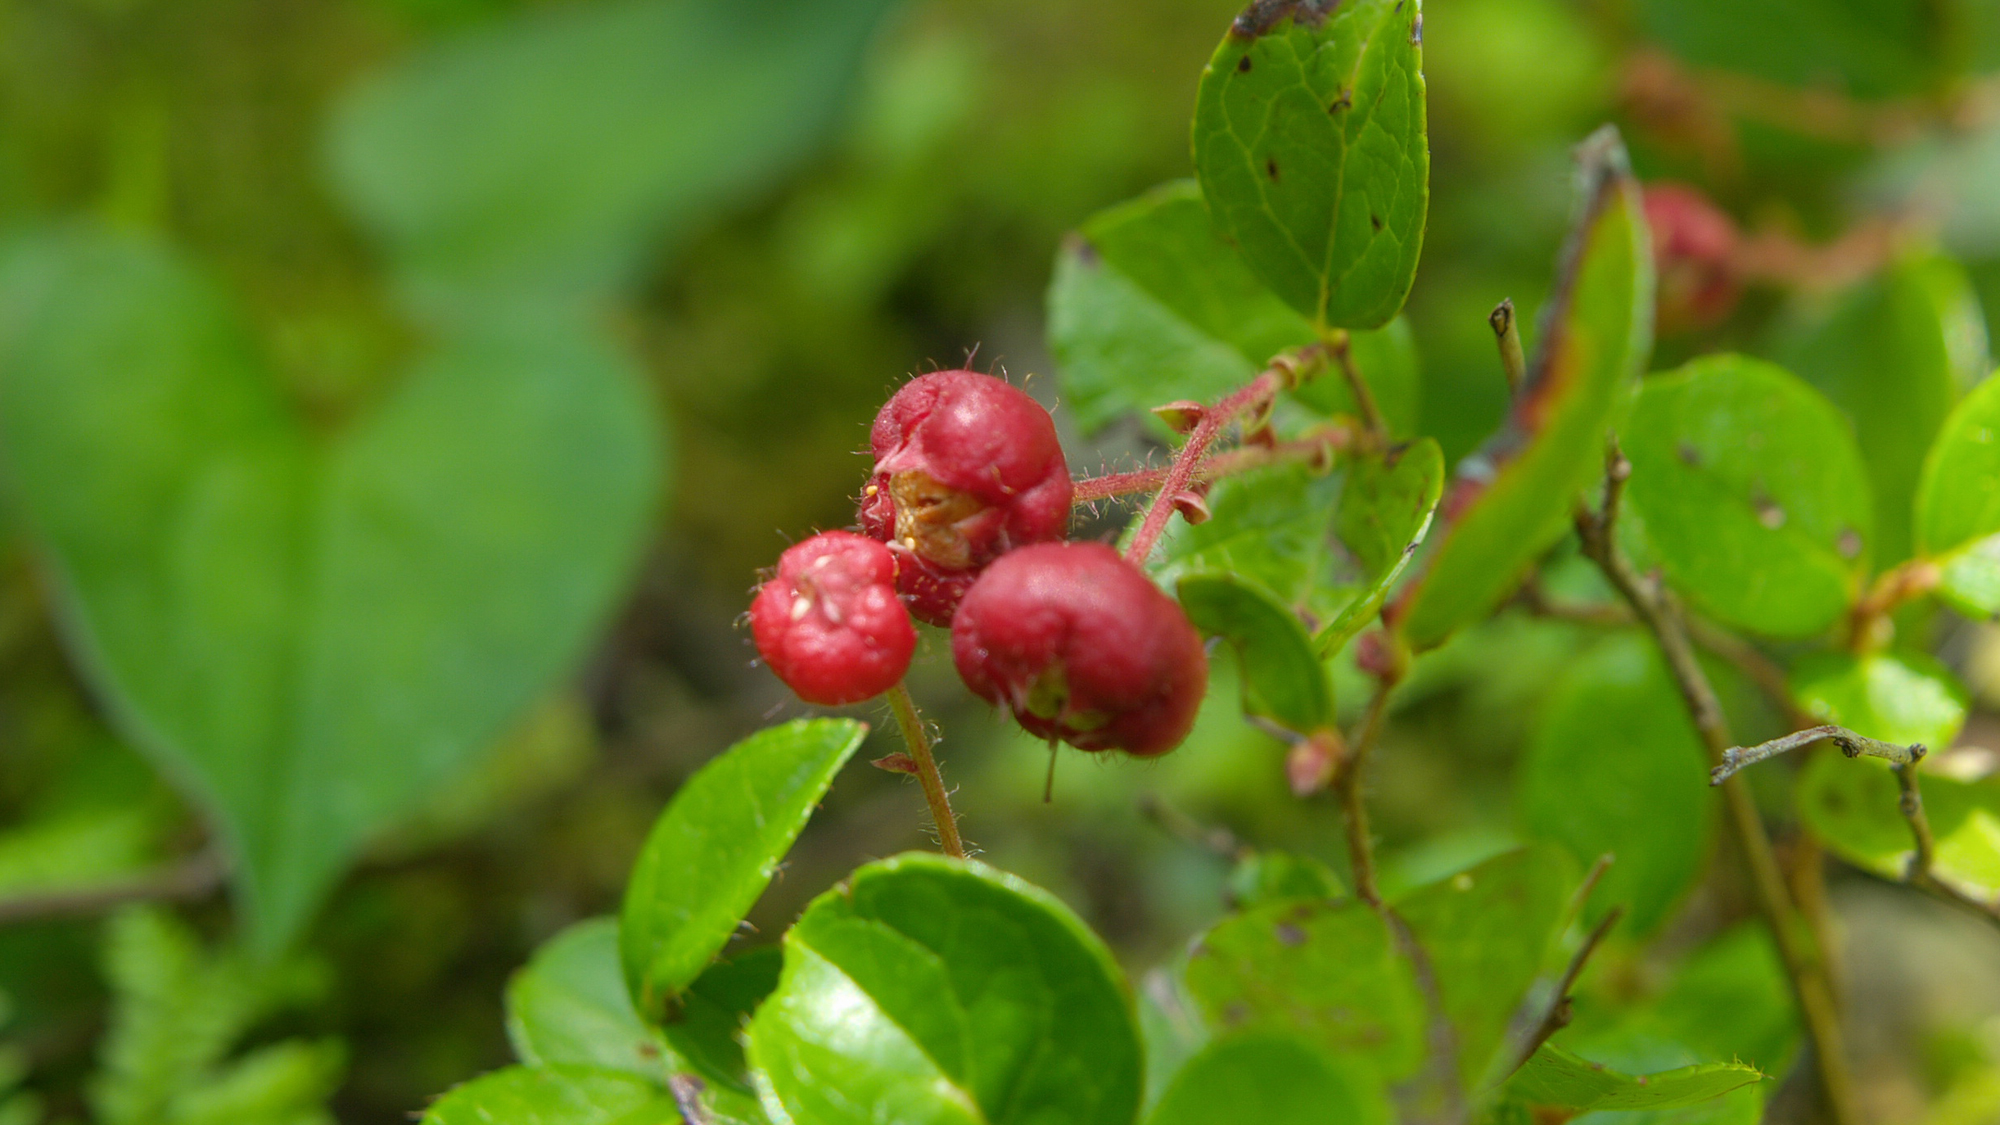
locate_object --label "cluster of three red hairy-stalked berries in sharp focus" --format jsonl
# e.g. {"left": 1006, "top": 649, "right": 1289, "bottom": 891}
{"left": 750, "top": 370, "right": 1208, "bottom": 757}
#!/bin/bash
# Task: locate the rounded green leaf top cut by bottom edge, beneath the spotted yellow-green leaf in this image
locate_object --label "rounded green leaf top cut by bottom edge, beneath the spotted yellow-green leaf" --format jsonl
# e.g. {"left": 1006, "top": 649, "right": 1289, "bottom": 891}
{"left": 1146, "top": 1031, "right": 1394, "bottom": 1125}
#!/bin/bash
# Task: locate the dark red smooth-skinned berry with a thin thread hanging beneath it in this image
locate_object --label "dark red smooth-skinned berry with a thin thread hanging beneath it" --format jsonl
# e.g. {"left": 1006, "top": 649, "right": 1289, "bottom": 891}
{"left": 952, "top": 542, "right": 1208, "bottom": 757}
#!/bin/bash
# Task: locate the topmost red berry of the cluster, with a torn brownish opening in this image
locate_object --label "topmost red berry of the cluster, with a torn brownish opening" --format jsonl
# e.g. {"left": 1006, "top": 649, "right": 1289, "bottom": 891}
{"left": 862, "top": 370, "right": 1072, "bottom": 625}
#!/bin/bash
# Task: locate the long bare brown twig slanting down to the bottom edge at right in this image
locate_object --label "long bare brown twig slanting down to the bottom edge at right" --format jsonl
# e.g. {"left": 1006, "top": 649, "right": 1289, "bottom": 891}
{"left": 1576, "top": 442, "right": 1860, "bottom": 1125}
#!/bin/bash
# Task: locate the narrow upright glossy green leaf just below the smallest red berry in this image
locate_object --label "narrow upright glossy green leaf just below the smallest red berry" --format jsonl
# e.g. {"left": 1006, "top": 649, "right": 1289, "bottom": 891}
{"left": 618, "top": 719, "right": 868, "bottom": 1023}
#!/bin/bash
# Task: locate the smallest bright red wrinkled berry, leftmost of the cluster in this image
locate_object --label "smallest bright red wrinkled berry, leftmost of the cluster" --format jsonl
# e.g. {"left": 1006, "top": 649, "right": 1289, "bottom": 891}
{"left": 750, "top": 530, "right": 916, "bottom": 707}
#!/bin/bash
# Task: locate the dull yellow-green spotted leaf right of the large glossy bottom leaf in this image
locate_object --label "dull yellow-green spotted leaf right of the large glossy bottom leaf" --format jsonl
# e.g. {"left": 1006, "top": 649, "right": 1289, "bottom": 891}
{"left": 1186, "top": 901, "right": 1424, "bottom": 1081}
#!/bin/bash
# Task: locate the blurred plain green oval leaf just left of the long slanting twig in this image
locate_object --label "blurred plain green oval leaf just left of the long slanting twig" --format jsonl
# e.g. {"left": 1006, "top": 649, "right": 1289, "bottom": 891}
{"left": 1514, "top": 635, "right": 1714, "bottom": 935}
